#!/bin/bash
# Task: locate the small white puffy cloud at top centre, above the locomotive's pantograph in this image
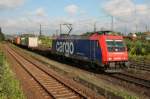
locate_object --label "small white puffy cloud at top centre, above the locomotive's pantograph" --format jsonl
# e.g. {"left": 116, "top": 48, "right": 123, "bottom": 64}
{"left": 65, "top": 4, "right": 79, "bottom": 15}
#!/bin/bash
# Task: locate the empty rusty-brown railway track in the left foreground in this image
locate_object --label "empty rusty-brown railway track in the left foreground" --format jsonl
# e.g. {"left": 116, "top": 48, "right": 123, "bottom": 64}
{"left": 5, "top": 46, "right": 103, "bottom": 99}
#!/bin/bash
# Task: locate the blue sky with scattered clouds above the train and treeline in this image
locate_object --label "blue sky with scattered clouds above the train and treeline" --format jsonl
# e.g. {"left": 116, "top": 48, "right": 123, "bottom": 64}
{"left": 0, "top": 0, "right": 150, "bottom": 35}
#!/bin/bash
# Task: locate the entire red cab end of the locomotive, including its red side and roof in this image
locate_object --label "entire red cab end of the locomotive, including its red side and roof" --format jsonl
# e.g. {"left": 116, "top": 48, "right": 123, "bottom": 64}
{"left": 90, "top": 33, "right": 128, "bottom": 72}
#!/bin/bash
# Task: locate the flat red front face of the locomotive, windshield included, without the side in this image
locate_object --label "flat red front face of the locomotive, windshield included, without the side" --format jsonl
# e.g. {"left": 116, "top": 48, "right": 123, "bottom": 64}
{"left": 105, "top": 36, "right": 128, "bottom": 68}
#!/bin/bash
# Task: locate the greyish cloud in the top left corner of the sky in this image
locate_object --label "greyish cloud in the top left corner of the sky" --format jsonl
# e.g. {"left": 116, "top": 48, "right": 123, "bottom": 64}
{"left": 0, "top": 0, "right": 24, "bottom": 10}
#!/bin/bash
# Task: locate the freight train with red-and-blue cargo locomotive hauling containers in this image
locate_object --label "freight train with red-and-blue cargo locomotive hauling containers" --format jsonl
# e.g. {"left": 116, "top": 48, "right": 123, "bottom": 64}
{"left": 12, "top": 31, "right": 128, "bottom": 72}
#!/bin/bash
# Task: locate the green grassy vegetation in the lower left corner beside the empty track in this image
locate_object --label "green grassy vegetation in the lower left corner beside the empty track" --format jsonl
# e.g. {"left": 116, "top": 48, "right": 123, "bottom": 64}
{"left": 0, "top": 45, "right": 25, "bottom": 99}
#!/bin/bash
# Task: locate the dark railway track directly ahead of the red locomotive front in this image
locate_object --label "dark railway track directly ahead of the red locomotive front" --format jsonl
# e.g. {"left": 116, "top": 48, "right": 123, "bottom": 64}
{"left": 110, "top": 73, "right": 150, "bottom": 89}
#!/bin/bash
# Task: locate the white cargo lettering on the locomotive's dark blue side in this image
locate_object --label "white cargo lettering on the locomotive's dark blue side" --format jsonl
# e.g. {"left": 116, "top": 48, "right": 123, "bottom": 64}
{"left": 56, "top": 41, "right": 74, "bottom": 55}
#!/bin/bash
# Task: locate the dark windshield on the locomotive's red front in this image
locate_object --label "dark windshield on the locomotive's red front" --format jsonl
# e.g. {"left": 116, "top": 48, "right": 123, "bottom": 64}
{"left": 106, "top": 40, "right": 125, "bottom": 52}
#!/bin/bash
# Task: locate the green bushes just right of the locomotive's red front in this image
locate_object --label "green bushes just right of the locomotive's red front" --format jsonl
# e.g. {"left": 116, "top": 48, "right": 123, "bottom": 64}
{"left": 125, "top": 39, "right": 150, "bottom": 71}
